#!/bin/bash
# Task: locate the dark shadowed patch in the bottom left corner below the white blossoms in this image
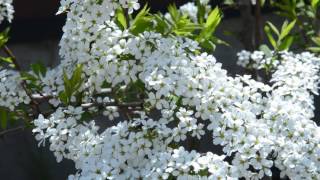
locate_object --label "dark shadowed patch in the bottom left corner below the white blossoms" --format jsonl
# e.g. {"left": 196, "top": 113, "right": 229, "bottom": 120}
{"left": 0, "top": 130, "right": 75, "bottom": 180}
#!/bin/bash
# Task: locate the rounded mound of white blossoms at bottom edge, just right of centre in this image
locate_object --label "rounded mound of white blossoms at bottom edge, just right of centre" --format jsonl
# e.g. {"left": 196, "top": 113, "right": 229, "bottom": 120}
{"left": 146, "top": 147, "right": 236, "bottom": 180}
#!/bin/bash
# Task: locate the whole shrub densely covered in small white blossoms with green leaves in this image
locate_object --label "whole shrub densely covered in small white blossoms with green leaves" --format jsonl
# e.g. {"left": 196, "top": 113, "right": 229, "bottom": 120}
{"left": 0, "top": 0, "right": 320, "bottom": 179}
